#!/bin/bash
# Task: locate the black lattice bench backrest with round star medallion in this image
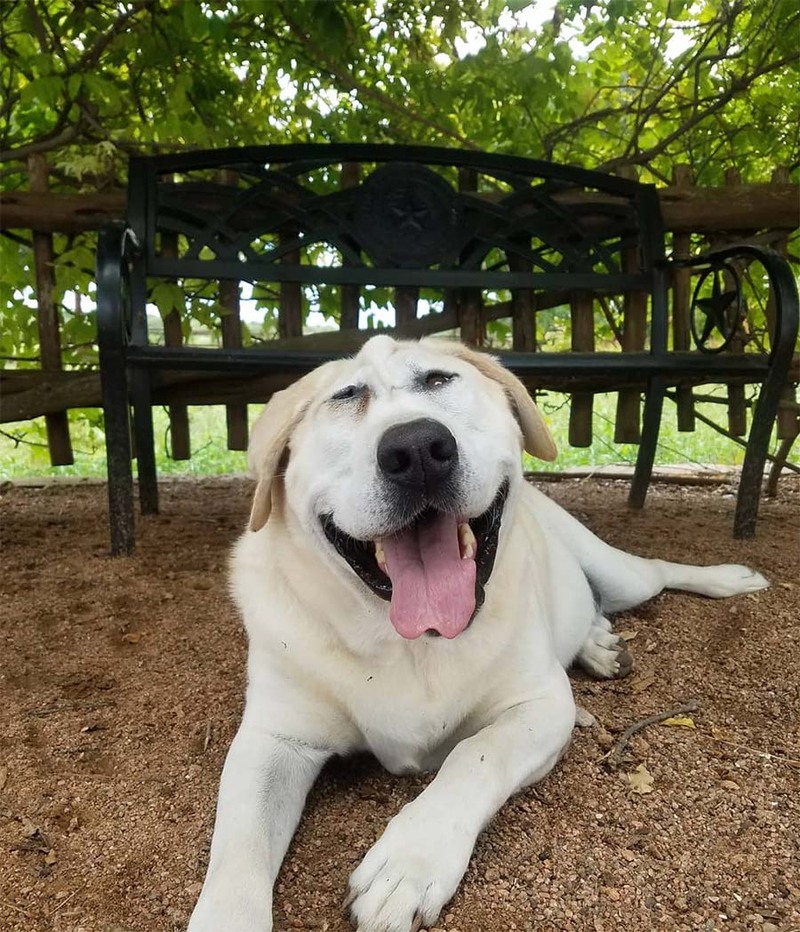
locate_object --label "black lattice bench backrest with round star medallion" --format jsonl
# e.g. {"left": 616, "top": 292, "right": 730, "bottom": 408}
{"left": 128, "top": 144, "right": 666, "bottom": 342}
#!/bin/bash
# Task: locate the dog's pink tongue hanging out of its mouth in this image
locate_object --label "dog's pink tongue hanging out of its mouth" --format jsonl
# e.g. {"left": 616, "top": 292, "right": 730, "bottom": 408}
{"left": 383, "top": 515, "right": 475, "bottom": 638}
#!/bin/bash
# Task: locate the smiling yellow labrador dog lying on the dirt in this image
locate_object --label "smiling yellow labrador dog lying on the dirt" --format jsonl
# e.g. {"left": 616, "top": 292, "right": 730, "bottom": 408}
{"left": 189, "top": 336, "right": 767, "bottom": 932}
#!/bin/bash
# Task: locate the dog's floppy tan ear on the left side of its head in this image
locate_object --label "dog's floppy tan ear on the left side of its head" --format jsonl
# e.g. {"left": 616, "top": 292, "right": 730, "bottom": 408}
{"left": 247, "top": 360, "right": 343, "bottom": 531}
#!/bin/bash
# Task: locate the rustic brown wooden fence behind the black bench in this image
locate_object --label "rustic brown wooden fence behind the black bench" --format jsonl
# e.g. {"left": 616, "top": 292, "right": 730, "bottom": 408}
{"left": 0, "top": 162, "right": 800, "bottom": 465}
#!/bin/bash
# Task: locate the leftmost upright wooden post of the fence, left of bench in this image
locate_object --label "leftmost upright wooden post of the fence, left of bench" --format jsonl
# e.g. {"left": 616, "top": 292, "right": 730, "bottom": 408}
{"left": 28, "top": 153, "right": 75, "bottom": 474}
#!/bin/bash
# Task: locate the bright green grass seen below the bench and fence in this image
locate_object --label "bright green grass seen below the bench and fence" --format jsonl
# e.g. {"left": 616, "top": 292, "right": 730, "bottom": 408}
{"left": 0, "top": 388, "right": 764, "bottom": 479}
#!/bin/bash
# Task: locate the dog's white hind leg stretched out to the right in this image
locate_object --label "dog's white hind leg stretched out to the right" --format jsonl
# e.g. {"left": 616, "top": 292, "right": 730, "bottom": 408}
{"left": 535, "top": 491, "right": 769, "bottom": 613}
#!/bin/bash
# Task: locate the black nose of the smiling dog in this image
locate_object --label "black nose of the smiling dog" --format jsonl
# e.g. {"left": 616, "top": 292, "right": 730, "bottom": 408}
{"left": 378, "top": 418, "right": 458, "bottom": 492}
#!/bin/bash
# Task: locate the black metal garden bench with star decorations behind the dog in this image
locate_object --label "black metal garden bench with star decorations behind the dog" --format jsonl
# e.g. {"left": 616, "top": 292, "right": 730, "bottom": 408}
{"left": 97, "top": 144, "right": 798, "bottom": 553}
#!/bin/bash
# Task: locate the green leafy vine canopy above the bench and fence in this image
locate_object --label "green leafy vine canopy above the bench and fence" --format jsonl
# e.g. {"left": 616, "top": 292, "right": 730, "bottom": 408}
{"left": 0, "top": 0, "right": 800, "bottom": 190}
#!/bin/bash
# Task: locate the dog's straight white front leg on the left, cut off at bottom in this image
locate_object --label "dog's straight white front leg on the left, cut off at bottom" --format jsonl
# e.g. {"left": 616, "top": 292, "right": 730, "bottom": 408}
{"left": 189, "top": 713, "right": 330, "bottom": 932}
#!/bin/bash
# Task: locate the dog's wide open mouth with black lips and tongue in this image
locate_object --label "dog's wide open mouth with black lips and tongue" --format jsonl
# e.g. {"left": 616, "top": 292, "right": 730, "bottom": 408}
{"left": 320, "top": 480, "right": 509, "bottom": 638}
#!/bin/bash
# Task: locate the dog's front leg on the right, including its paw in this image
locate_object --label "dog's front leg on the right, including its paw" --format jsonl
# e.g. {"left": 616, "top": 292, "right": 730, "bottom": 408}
{"left": 349, "top": 668, "right": 575, "bottom": 932}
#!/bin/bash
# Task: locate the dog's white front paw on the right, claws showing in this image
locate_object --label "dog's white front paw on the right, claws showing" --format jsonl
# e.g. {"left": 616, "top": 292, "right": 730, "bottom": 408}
{"left": 345, "top": 803, "right": 472, "bottom": 932}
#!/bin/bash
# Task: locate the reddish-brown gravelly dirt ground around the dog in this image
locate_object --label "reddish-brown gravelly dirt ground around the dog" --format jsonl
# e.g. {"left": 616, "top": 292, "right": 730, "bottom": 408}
{"left": 0, "top": 478, "right": 800, "bottom": 932}
